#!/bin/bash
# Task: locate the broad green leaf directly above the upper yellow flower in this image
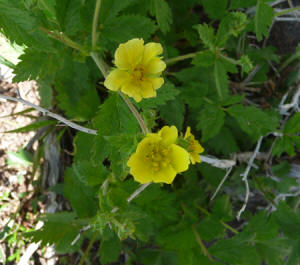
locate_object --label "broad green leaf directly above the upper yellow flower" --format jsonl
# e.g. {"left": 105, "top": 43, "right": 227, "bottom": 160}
{"left": 99, "top": 15, "right": 155, "bottom": 44}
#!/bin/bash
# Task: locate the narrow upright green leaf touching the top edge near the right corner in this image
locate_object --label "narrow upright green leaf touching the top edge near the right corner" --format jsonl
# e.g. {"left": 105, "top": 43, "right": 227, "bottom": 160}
{"left": 254, "top": 0, "right": 274, "bottom": 41}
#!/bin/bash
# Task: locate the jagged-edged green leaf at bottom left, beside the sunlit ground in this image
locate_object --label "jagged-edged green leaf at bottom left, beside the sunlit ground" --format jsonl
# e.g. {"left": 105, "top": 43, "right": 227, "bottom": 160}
{"left": 25, "top": 212, "right": 82, "bottom": 253}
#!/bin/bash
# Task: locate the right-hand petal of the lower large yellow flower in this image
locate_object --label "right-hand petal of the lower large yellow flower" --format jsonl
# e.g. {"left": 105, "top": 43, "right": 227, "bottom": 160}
{"left": 170, "top": 144, "right": 190, "bottom": 172}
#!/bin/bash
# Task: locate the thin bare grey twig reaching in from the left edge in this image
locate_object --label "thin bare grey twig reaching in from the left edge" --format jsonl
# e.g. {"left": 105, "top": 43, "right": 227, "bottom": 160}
{"left": 0, "top": 94, "right": 97, "bottom": 135}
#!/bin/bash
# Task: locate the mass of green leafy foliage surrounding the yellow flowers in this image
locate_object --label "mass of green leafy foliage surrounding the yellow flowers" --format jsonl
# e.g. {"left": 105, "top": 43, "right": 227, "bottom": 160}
{"left": 0, "top": 0, "right": 300, "bottom": 265}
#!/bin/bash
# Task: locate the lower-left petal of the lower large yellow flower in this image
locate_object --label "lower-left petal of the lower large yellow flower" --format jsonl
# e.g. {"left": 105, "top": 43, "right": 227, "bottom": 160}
{"left": 127, "top": 153, "right": 153, "bottom": 184}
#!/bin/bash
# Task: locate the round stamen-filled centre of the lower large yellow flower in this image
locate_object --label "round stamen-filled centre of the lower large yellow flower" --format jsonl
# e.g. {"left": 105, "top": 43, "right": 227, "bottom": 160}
{"left": 145, "top": 143, "right": 171, "bottom": 172}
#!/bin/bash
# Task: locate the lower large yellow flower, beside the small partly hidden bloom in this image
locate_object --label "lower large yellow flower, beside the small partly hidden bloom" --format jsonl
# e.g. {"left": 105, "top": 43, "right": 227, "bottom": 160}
{"left": 127, "top": 126, "right": 190, "bottom": 184}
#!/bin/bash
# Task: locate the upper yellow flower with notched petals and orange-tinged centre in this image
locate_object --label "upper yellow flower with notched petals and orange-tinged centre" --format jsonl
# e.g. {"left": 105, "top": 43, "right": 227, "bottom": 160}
{"left": 104, "top": 39, "right": 166, "bottom": 102}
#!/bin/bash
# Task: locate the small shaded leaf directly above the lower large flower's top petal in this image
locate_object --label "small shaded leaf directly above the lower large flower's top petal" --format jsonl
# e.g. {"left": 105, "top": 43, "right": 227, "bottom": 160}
{"left": 159, "top": 98, "right": 185, "bottom": 131}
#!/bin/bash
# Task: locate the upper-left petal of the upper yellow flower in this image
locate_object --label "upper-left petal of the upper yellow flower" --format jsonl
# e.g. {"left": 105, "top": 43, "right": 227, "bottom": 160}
{"left": 115, "top": 39, "right": 144, "bottom": 70}
